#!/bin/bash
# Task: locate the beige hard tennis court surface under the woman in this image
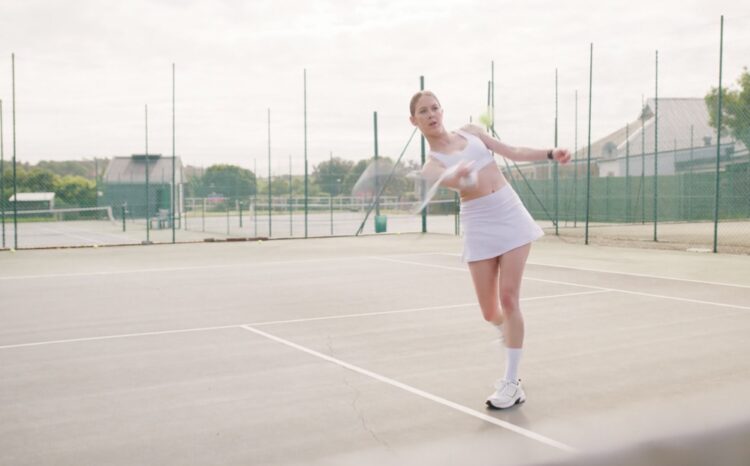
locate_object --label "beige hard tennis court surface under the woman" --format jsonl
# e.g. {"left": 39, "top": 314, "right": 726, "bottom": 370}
{"left": 0, "top": 234, "right": 750, "bottom": 465}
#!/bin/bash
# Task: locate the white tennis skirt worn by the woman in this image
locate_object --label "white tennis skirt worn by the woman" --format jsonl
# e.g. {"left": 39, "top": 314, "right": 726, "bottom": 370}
{"left": 461, "top": 184, "right": 544, "bottom": 262}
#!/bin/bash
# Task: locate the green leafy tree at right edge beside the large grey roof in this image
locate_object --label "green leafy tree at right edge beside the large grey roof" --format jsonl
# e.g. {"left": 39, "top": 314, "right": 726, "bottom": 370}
{"left": 705, "top": 67, "right": 750, "bottom": 149}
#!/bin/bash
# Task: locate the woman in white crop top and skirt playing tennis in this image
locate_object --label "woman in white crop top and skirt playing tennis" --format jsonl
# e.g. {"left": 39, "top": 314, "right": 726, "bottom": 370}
{"left": 409, "top": 91, "right": 570, "bottom": 409}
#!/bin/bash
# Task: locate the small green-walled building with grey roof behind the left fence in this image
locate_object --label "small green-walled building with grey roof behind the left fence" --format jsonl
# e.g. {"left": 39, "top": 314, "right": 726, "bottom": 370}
{"left": 99, "top": 154, "right": 184, "bottom": 218}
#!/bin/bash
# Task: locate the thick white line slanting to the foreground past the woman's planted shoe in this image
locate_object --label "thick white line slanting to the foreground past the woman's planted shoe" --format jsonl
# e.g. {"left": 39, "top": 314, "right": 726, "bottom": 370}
{"left": 242, "top": 325, "right": 577, "bottom": 453}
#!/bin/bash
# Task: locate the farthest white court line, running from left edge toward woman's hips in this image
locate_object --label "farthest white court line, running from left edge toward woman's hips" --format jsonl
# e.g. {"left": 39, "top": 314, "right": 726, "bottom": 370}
{"left": 0, "top": 252, "right": 439, "bottom": 281}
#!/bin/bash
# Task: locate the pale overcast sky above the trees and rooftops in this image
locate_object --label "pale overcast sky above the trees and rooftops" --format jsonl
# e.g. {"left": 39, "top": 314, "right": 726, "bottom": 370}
{"left": 0, "top": 0, "right": 750, "bottom": 174}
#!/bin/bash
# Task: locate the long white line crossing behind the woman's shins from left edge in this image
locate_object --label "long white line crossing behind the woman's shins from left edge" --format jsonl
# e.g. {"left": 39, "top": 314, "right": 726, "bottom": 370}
{"left": 0, "top": 290, "right": 603, "bottom": 350}
